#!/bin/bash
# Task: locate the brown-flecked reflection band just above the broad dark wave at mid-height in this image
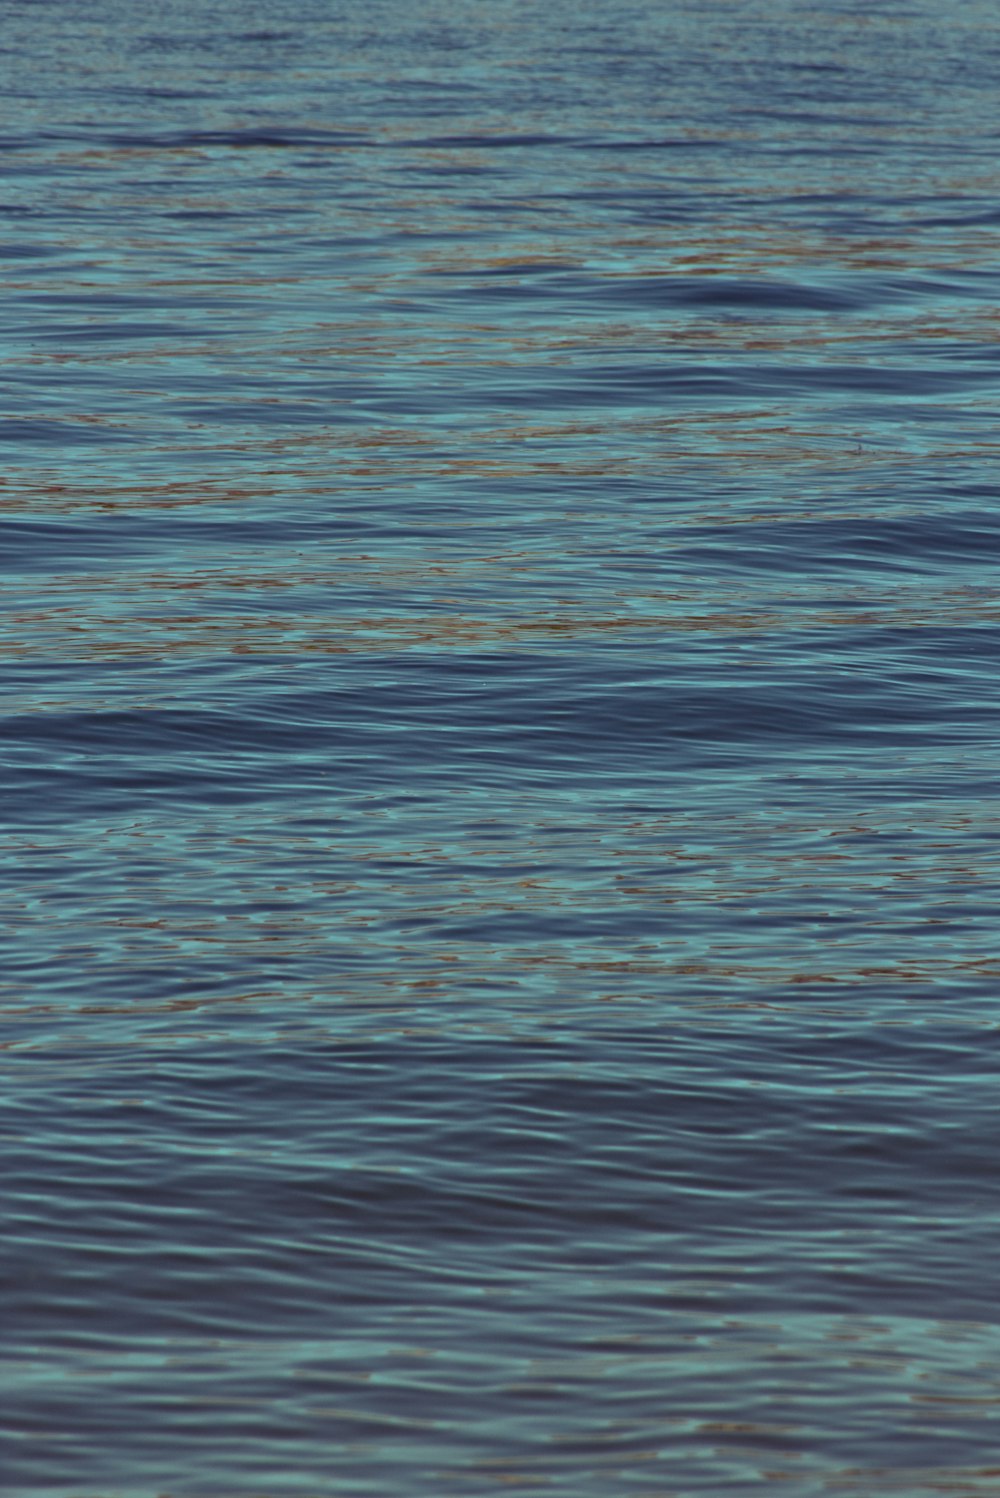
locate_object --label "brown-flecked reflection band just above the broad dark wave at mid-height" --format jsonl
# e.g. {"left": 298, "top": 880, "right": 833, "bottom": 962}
{"left": 4, "top": 575, "right": 1000, "bottom": 665}
